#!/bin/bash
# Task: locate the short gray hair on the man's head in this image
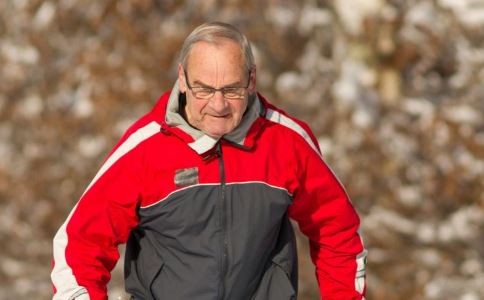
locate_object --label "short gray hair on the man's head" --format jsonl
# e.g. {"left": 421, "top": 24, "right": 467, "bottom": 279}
{"left": 179, "top": 22, "right": 255, "bottom": 72}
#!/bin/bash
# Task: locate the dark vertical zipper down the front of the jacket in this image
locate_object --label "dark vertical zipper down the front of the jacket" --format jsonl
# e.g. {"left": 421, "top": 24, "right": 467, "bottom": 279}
{"left": 216, "top": 141, "right": 228, "bottom": 299}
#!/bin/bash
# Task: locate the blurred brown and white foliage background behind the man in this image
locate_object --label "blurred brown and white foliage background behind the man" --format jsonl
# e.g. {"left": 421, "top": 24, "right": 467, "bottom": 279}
{"left": 0, "top": 0, "right": 484, "bottom": 300}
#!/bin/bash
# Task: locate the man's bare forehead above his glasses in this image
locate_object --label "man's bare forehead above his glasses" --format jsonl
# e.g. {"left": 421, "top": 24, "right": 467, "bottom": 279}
{"left": 187, "top": 39, "right": 245, "bottom": 73}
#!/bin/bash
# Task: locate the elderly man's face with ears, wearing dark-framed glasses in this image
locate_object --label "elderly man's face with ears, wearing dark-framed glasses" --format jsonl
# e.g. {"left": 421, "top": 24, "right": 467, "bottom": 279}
{"left": 178, "top": 40, "right": 255, "bottom": 138}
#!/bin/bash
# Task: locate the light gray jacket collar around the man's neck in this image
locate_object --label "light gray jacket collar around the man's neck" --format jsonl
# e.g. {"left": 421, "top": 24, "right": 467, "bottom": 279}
{"left": 165, "top": 80, "right": 265, "bottom": 154}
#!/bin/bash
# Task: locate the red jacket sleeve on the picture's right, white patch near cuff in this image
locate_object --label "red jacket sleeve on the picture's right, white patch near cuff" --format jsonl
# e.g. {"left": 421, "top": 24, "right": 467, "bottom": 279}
{"left": 289, "top": 123, "right": 366, "bottom": 300}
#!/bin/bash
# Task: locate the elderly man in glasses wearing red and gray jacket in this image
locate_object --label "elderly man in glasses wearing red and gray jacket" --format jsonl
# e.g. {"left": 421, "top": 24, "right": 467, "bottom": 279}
{"left": 52, "top": 22, "right": 366, "bottom": 300}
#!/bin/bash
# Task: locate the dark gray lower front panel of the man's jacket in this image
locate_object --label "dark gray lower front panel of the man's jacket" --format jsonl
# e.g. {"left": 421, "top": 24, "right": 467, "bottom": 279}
{"left": 125, "top": 183, "right": 297, "bottom": 300}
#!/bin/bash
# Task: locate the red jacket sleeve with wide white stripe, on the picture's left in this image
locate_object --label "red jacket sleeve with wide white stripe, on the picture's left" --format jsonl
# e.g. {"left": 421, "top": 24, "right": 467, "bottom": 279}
{"left": 51, "top": 122, "right": 155, "bottom": 300}
